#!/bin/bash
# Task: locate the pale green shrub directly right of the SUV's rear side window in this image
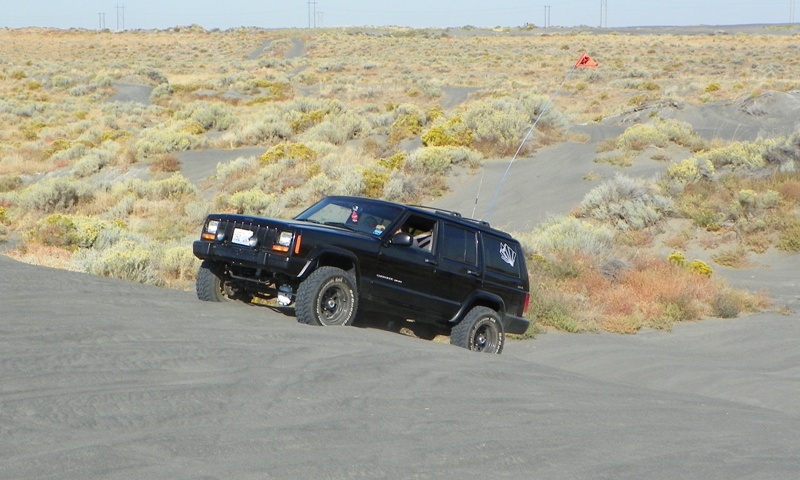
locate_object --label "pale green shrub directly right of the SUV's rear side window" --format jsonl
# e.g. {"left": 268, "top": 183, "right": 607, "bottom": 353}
{"left": 518, "top": 217, "right": 614, "bottom": 257}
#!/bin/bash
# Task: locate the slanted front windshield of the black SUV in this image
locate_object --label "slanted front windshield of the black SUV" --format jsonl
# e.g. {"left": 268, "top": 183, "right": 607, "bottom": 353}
{"left": 296, "top": 197, "right": 402, "bottom": 235}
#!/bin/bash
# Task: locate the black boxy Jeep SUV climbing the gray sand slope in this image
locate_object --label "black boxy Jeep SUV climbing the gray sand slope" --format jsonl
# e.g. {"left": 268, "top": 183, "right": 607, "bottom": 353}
{"left": 193, "top": 196, "right": 530, "bottom": 353}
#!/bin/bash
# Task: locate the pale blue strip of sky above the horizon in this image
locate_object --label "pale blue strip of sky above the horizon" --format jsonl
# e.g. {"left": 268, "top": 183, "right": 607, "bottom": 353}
{"left": 0, "top": 0, "right": 800, "bottom": 30}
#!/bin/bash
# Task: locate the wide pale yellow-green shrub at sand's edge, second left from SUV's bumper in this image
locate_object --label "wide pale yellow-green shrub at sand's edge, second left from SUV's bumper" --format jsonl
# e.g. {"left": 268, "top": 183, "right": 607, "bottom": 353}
{"left": 73, "top": 240, "right": 163, "bottom": 285}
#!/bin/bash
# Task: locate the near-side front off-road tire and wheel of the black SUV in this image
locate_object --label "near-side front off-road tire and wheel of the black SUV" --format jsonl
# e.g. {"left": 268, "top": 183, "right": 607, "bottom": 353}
{"left": 295, "top": 267, "right": 358, "bottom": 327}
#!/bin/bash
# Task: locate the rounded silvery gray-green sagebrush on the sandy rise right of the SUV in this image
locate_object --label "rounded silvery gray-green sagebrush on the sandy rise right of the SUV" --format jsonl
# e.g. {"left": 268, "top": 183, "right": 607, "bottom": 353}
{"left": 580, "top": 174, "right": 674, "bottom": 230}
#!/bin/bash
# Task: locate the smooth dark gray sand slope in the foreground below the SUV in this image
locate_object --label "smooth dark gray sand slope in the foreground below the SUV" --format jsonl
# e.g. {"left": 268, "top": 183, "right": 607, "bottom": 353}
{"left": 0, "top": 256, "right": 800, "bottom": 480}
